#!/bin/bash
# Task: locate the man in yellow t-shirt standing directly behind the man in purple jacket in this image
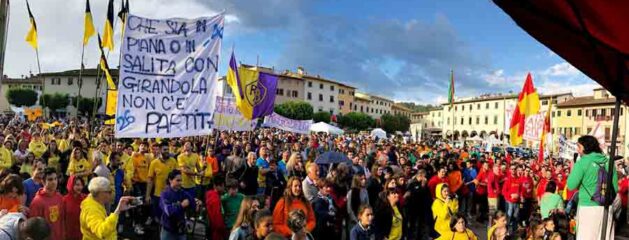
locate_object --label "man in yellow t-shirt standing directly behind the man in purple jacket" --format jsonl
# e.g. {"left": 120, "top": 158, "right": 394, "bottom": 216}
{"left": 144, "top": 144, "right": 177, "bottom": 222}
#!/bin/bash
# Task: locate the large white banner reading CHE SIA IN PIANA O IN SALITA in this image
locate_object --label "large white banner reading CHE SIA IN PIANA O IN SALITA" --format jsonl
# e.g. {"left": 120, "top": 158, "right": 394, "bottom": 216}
{"left": 115, "top": 13, "right": 224, "bottom": 138}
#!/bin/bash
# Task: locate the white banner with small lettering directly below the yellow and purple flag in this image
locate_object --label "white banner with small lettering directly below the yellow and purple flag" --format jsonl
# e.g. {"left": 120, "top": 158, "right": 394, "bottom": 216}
{"left": 214, "top": 96, "right": 257, "bottom": 132}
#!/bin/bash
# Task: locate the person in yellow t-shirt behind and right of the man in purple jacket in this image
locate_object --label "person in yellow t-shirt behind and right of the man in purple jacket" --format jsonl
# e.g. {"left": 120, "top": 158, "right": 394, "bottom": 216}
{"left": 177, "top": 141, "right": 200, "bottom": 196}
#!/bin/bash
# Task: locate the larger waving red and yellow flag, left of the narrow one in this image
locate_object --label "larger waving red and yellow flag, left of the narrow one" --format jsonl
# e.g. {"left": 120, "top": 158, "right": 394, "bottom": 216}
{"left": 509, "top": 73, "right": 539, "bottom": 146}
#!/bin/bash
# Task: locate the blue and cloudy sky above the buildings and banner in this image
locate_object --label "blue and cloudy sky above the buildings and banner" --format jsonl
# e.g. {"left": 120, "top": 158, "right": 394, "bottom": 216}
{"left": 5, "top": 0, "right": 598, "bottom": 104}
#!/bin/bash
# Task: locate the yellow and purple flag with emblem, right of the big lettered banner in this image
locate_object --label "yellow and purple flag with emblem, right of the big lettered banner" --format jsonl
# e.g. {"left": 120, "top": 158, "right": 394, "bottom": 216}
{"left": 227, "top": 52, "right": 277, "bottom": 120}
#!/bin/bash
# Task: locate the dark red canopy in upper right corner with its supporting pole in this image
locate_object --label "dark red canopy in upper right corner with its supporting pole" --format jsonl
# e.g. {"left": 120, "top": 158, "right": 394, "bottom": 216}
{"left": 494, "top": 0, "right": 629, "bottom": 239}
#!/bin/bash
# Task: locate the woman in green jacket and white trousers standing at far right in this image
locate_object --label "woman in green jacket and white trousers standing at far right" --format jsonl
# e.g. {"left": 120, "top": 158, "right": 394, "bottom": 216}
{"left": 567, "top": 135, "right": 618, "bottom": 239}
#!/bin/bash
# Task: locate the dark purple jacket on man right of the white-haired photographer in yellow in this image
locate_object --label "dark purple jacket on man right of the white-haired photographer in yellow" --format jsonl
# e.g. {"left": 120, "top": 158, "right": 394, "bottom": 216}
{"left": 159, "top": 186, "right": 196, "bottom": 234}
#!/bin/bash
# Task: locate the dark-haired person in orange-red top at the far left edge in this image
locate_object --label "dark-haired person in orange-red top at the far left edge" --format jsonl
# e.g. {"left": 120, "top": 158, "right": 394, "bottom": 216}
{"left": 0, "top": 174, "right": 28, "bottom": 212}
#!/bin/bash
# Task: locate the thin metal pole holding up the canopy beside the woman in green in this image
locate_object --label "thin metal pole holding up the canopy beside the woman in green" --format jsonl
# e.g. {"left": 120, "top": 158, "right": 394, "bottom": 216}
{"left": 601, "top": 97, "right": 623, "bottom": 240}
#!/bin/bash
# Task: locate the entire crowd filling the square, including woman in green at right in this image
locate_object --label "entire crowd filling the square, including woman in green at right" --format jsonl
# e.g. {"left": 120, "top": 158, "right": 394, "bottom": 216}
{"left": 0, "top": 117, "right": 629, "bottom": 240}
